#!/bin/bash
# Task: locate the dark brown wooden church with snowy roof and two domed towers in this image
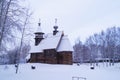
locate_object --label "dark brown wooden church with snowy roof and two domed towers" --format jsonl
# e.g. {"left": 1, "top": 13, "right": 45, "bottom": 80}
{"left": 28, "top": 20, "right": 73, "bottom": 64}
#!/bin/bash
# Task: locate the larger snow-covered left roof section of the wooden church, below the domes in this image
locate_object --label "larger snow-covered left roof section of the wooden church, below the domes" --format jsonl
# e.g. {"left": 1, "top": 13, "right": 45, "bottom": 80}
{"left": 30, "top": 32, "right": 62, "bottom": 53}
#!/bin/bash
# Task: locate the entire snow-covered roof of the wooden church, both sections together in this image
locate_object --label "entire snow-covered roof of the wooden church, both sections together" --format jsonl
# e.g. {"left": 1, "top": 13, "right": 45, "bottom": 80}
{"left": 30, "top": 32, "right": 73, "bottom": 53}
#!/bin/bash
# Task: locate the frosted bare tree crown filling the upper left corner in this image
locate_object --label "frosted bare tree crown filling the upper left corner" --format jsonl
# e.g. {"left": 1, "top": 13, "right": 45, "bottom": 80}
{"left": 0, "top": 0, "right": 26, "bottom": 51}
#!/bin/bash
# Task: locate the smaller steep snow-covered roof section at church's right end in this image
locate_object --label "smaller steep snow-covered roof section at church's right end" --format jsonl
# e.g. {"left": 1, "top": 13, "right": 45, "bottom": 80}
{"left": 57, "top": 36, "right": 73, "bottom": 52}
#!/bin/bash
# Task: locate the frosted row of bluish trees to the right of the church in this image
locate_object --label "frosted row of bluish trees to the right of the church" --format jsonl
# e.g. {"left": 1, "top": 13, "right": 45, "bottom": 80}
{"left": 73, "top": 27, "right": 120, "bottom": 63}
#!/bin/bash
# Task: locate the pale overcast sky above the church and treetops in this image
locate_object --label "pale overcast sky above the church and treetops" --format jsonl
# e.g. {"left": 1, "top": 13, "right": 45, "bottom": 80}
{"left": 27, "top": 0, "right": 120, "bottom": 44}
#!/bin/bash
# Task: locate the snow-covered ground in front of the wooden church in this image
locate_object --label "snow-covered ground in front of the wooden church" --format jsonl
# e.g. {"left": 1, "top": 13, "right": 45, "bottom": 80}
{"left": 0, "top": 63, "right": 120, "bottom": 80}
